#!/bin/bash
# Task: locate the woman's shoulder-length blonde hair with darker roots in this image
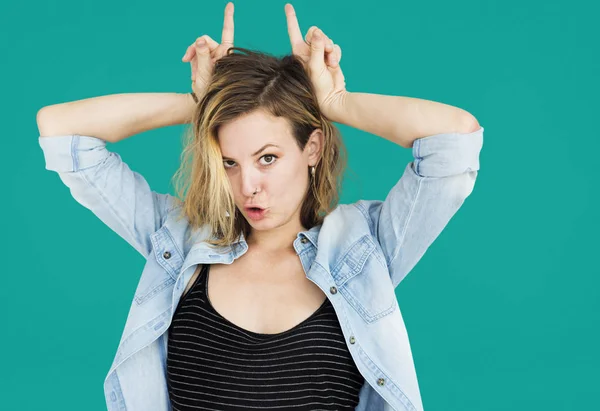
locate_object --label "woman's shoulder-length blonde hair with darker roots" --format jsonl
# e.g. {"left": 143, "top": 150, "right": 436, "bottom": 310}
{"left": 174, "top": 47, "right": 347, "bottom": 246}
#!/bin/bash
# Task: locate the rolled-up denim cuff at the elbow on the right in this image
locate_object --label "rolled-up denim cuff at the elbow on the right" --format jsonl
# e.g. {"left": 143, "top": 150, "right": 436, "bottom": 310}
{"left": 412, "top": 127, "right": 484, "bottom": 177}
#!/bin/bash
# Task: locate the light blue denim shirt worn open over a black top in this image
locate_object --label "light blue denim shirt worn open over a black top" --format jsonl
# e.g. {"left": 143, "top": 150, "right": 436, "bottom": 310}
{"left": 38, "top": 127, "right": 483, "bottom": 411}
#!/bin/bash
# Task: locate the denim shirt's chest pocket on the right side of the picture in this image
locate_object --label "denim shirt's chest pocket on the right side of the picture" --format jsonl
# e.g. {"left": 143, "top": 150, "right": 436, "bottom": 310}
{"left": 331, "top": 234, "right": 398, "bottom": 323}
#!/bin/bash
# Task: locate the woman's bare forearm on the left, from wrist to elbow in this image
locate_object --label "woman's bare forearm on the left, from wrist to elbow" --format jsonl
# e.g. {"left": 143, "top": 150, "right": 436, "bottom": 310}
{"left": 37, "top": 93, "right": 196, "bottom": 143}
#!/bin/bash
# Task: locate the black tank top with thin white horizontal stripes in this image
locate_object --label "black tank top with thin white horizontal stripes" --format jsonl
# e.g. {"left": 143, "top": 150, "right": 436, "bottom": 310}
{"left": 167, "top": 265, "right": 365, "bottom": 411}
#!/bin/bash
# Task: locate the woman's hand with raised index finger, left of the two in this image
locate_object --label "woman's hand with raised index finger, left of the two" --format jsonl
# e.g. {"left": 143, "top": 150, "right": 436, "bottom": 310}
{"left": 181, "top": 2, "right": 233, "bottom": 100}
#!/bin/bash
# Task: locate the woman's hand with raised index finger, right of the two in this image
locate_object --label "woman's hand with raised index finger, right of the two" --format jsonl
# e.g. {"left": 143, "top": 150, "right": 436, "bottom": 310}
{"left": 285, "top": 4, "right": 346, "bottom": 121}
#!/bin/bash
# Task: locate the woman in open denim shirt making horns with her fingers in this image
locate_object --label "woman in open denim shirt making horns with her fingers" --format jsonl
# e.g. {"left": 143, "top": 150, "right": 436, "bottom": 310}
{"left": 38, "top": 3, "right": 483, "bottom": 411}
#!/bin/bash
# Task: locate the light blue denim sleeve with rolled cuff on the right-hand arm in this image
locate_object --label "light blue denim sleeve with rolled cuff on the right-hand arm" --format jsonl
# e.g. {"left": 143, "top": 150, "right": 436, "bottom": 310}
{"left": 356, "top": 127, "right": 484, "bottom": 287}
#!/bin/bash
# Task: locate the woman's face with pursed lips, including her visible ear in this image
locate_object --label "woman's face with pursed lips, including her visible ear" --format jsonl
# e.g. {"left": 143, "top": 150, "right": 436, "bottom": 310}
{"left": 219, "top": 110, "right": 322, "bottom": 230}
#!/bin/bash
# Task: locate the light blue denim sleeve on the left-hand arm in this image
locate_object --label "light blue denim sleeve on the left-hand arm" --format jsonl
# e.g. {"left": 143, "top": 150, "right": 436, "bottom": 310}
{"left": 38, "top": 134, "right": 174, "bottom": 258}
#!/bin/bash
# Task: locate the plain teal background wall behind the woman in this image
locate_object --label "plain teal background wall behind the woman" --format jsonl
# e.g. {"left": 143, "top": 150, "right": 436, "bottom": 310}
{"left": 0, "top": 0, "right": 600, "bottom": 411}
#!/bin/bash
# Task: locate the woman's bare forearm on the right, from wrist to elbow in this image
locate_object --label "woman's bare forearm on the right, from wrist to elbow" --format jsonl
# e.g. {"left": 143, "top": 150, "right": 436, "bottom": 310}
{"left": 326, "top": 92, "right": 480, "bottom": 148}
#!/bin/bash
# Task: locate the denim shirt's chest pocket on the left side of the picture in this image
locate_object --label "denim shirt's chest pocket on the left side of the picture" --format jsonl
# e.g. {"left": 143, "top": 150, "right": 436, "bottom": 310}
{"left": 134, "top": 226, "right": 184, "bottom": 305}
